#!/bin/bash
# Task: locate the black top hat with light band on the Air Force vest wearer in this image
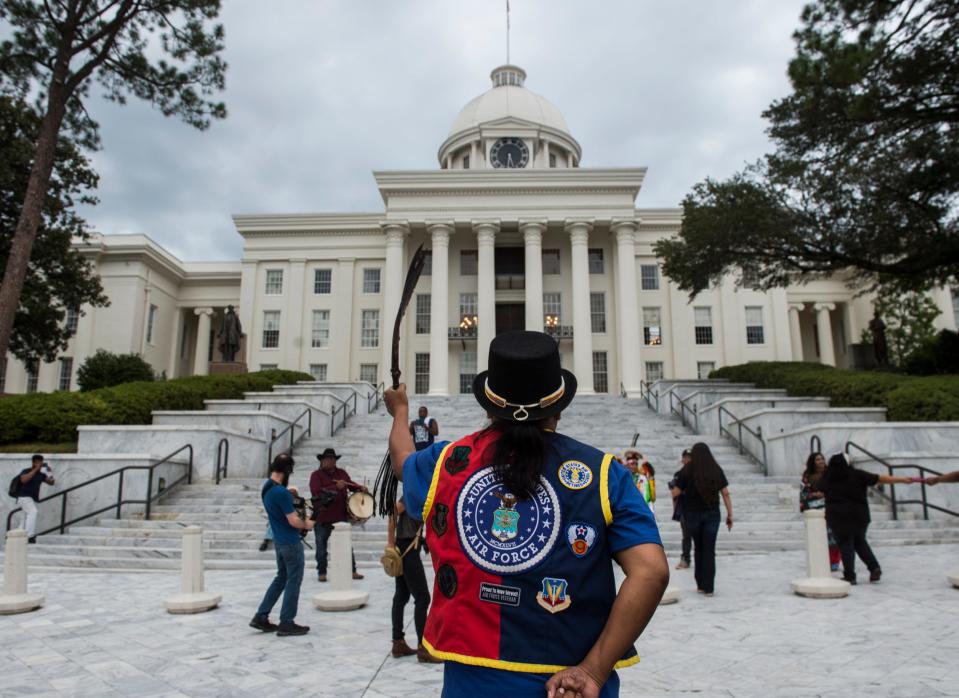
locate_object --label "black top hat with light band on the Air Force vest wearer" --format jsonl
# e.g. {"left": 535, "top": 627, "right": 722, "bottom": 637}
{"left": 473, "top": 332, "right": 576, "bottom": 422}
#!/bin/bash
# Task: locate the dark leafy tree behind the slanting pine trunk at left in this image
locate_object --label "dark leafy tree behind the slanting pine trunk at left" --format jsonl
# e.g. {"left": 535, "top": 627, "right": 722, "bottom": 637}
{"left": 0, "top": 95, "right": 107, "bottom": 365}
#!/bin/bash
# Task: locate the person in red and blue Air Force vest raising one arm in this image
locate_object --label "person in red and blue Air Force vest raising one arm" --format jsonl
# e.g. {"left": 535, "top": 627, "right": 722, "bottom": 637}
{"left": 385, "top": 332, "right": 669, "bottom": 698}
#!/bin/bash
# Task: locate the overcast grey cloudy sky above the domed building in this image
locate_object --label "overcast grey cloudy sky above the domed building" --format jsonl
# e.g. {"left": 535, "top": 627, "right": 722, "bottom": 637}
{"left": 73, "top": 0, "right": 803, "bottom": 261}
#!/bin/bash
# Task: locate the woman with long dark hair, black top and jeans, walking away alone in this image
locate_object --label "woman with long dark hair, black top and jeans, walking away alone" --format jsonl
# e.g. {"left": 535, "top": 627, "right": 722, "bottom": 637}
{"left": 673, "top": 443, "right": 733, "bottom": 596}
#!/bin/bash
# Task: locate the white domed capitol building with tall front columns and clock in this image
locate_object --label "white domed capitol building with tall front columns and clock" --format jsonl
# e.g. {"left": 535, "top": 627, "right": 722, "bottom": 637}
{"left": 0, "top": 65, "right": 959, "bottom": 395}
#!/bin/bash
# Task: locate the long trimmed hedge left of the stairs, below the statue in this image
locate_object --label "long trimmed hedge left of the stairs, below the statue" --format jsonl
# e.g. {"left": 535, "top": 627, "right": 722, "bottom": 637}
{"left": 0, "top": 370, "right": 312, "bottom": 444}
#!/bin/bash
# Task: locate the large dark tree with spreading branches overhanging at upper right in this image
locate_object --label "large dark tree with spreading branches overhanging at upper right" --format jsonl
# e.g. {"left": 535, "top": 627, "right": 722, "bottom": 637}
{"left": 654, "top": 0, "right": 959, "bottom": 295}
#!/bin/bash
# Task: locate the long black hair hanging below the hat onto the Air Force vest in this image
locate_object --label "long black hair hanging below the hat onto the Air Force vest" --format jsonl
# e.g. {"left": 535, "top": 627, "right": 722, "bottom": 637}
{"left": 483, "top": 419, "right": 552, "bottom": 500}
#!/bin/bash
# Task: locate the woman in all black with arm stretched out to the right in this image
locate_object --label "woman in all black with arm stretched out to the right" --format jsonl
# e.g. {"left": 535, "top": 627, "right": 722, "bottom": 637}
{"left": 819, "top": 453, "right": 912, "bottom": 584}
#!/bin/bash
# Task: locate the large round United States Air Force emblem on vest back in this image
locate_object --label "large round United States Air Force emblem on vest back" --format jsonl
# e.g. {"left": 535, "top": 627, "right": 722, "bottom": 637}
{"left": 456, "top": 466, "right": 561, "bottom": 574}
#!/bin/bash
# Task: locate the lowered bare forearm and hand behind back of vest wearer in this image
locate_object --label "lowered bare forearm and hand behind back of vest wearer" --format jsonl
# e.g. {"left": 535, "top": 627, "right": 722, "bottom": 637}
{"left": 546, "top": 543, "right": 669, "bottom": 698}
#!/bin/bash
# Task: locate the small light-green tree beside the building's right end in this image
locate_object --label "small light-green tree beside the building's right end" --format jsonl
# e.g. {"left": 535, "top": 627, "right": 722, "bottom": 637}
{"left": 862, "top": 286, "right": 941, "bottom": 366}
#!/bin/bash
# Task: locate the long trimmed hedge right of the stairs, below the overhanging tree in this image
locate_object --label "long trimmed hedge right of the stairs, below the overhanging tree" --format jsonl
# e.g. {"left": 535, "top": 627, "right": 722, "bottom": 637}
{"left": 709, "top": 361, "right": 959, "bottom": 422}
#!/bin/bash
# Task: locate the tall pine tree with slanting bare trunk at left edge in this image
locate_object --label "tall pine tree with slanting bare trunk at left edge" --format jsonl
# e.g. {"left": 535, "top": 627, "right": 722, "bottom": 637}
{"left": 0, "top": 0, "right": 226, "bottom": 364}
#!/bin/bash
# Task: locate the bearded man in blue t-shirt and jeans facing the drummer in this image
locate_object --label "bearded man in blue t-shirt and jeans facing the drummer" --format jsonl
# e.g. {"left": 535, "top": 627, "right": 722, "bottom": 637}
{"left": 250, "top": 453, "right": 313, "bottom": 636}
